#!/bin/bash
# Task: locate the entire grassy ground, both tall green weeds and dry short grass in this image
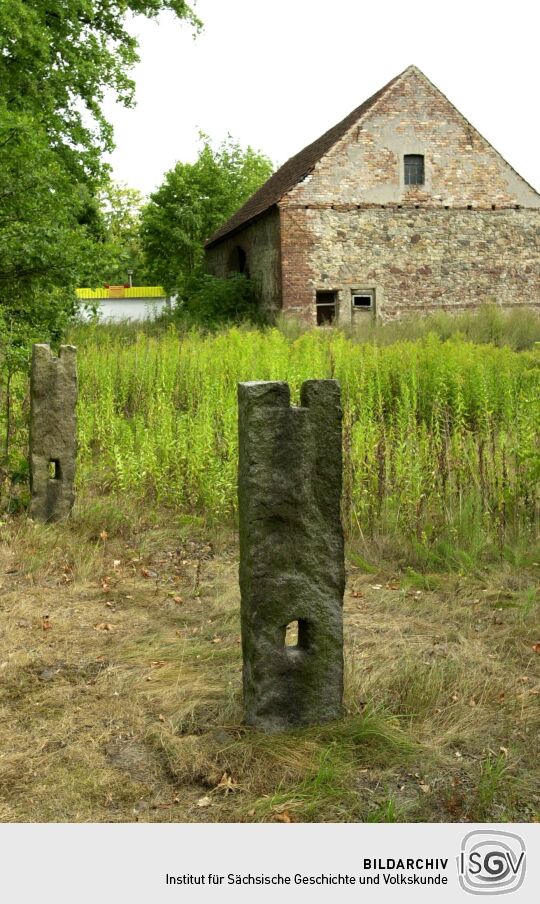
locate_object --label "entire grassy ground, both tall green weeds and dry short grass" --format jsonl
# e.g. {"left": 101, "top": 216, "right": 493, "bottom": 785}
{"left": 0, "top": 312, "right": 540, "bottom": 822}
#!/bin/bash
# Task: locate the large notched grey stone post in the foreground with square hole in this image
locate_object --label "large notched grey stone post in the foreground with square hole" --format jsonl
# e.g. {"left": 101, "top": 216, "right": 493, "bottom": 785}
{"left": 238, "top": 380, "right": 345, "bottom": 731}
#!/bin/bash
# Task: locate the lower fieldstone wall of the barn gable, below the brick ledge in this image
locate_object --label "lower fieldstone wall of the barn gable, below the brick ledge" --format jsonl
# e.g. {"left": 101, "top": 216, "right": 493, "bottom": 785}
{"left": 282, "top": 208, "right": 540, "bottom": 323}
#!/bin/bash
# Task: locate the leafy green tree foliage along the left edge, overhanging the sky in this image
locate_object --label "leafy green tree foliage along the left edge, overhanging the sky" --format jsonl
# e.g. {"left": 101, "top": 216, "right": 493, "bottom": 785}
{"left": 0, "top": 0, "right": 199, "bottom": 342}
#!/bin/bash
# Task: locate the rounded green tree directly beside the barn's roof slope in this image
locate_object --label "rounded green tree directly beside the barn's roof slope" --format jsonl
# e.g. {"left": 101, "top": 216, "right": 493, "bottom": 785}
{"left": 142, "top": 134, "right": 272, "bottom": 292}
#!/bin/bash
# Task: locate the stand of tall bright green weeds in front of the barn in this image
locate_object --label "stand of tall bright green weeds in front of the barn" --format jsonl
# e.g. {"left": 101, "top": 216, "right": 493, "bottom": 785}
{"left": 69, "top": 327, "right": 540, "bottom": 564}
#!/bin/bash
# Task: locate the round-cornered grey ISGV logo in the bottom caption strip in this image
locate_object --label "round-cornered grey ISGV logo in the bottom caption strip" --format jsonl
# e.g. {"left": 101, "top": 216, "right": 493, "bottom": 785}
{"left": 457, "top": 829, "right": 526, "bottom": 895}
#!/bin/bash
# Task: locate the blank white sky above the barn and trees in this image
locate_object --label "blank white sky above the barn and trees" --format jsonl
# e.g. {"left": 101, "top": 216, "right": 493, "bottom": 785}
{"left": 102, "top": 0, "right": 540, "bottom": 193}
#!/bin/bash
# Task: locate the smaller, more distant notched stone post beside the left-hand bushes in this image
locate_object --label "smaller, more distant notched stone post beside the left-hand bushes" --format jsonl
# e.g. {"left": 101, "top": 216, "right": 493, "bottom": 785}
{"left": 30, "top": 344, "right": 77, "bottom": 521}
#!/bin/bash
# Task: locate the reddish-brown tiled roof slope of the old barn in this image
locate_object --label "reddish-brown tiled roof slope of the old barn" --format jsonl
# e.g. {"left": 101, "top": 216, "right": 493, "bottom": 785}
{"left": 206, "top": 66, "right": 415, "bottom": 248}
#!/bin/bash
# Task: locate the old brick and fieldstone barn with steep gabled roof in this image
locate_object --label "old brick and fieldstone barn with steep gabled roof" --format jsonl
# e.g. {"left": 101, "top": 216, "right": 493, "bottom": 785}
{"left": 206, "top": 66, "right": 540, "bottom": 324}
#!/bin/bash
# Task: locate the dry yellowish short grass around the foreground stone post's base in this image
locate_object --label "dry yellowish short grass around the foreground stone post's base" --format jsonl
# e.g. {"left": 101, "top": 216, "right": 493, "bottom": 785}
{"left": 0, "top": 499, "right": 540, "bottom": 822}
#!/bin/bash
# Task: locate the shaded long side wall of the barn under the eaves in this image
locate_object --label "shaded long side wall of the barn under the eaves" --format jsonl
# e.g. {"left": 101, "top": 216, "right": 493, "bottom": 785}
{"left": 205, "top": 210, "right": 281, "bottom": 310}
